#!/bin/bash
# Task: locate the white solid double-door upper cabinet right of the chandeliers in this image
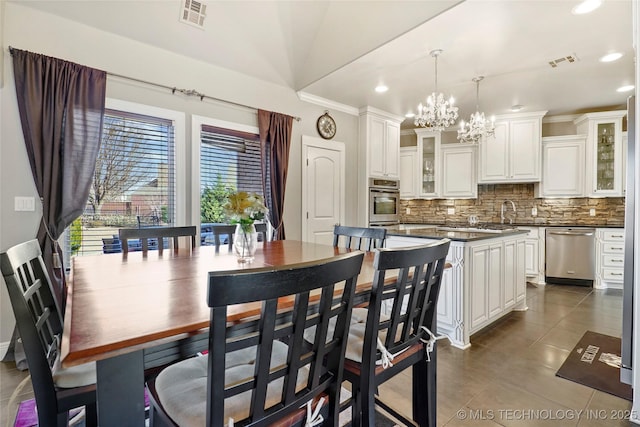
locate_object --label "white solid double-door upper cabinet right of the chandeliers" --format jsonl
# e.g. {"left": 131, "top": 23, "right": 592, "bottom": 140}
{"left": 478, "top": 111, "right": 546, "bottom": 184}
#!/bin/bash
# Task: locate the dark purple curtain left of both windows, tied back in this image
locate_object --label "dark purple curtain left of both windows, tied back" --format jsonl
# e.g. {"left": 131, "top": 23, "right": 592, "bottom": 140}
{"left": 11, "top": 49, "right": 107, "bottom": 313}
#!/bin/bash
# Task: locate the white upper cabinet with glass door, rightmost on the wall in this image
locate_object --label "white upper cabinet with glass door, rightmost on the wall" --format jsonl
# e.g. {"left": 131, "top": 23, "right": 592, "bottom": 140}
{"left": 574, "top": 110, "right": 627, "bottom": 197}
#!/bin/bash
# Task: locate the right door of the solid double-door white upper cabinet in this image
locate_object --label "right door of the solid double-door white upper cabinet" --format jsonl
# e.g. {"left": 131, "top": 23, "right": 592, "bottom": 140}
{"left": 508, "top": 119, "right": 540, "bottom": 181}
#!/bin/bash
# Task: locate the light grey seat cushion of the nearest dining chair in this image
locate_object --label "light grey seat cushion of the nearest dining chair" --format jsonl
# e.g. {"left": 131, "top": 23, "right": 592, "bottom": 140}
{"left": 155, "top": 341, "right": 309, "bottom": 427}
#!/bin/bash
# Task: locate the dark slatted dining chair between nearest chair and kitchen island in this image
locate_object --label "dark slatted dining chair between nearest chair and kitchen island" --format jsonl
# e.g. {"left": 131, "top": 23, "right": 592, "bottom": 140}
{"left": 345, "top": 239, "right": 450, "bottom": 426}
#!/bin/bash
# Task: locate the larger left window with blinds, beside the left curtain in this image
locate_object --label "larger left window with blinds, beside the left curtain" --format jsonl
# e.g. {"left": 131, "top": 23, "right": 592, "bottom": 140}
{"left": 65, "top": 105, "right": 176, "bottom": 260}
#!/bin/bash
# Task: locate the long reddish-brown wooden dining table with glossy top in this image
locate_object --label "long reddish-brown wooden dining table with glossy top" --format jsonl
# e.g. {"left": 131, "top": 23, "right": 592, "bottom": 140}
{"left": 61, "top": 240, "right": 435, "bottom": 427}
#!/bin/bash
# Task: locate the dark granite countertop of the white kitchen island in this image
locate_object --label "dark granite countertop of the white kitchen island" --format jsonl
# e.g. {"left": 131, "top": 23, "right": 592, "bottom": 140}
{"left": 385, "top": 224, "right": 529, "bottom": 242}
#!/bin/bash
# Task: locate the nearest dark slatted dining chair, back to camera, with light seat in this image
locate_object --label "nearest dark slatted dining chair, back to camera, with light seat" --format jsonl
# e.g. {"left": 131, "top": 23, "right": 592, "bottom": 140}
{"left": 148, "top": 251, "right": 364, "bottom": 427}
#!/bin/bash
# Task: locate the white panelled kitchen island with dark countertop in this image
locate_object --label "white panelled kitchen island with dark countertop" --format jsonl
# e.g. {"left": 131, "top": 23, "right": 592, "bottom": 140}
{"left": 386, "top": 224, "right": 528, "bottom": 349}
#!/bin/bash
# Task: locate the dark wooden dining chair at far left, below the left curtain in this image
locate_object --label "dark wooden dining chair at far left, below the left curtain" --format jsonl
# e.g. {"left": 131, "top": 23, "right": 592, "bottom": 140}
{"left": 0, "top": 240, "right": 97, "bottom": 427}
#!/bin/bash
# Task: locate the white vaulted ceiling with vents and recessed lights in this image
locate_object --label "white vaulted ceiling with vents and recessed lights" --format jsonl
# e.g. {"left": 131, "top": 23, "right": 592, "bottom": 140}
{"left": 13, "top": 0, "right": 634, "bottom": 122}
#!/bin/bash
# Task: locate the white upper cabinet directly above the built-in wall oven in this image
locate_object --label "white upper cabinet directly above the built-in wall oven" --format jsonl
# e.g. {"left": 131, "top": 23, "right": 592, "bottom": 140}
{"left": 360, "top": 107, "right": 404, "bottom": 178}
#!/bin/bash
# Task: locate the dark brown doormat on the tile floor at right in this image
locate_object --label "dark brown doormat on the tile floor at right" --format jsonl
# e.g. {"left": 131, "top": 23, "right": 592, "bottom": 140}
{"left": 556, "top": 331, "right": 633, "bottom": 401}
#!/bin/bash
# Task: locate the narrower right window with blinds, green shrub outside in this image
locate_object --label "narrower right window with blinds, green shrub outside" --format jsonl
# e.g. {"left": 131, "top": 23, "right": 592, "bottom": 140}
{"left": 200, "top": 124, "right": 263, "bottom": 245}
